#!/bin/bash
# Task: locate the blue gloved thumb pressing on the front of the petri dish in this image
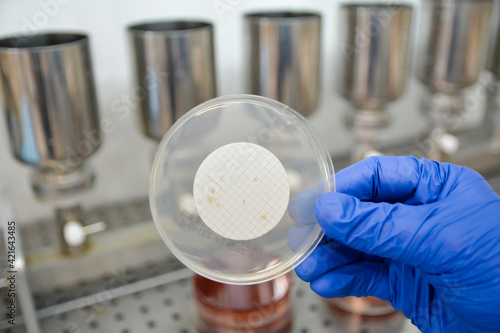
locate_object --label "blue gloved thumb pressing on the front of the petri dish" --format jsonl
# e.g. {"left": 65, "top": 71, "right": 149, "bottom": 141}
{"left": 315, "top": 192, "right": 434, "bottom": 267}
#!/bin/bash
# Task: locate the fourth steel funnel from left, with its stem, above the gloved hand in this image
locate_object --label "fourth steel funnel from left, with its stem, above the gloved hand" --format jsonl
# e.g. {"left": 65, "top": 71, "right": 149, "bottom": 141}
{"left": 338, "top": 4, "right": 413, "bottom": 162}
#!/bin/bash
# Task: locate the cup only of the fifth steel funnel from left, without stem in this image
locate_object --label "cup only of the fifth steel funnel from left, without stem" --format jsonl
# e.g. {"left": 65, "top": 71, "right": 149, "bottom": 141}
{"left": 417, "top": 0, "right": 493, "bottom": 94}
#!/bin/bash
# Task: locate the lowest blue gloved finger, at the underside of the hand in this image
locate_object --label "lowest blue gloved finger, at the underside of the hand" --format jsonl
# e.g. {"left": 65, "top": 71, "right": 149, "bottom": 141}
{"left": 311, "top": 261, "right": 390, "bottom": 300}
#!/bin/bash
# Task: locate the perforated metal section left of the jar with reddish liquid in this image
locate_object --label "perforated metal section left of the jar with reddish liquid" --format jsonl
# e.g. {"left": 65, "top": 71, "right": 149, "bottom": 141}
{"left": 34, "top": 279, "right": 193, "bottom": 333}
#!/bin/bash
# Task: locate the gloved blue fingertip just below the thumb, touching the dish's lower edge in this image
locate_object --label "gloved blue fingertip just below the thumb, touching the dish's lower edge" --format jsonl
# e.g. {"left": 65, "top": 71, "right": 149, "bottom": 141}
{"left": 295, "top": 241, "right": 365, "bottom": 282}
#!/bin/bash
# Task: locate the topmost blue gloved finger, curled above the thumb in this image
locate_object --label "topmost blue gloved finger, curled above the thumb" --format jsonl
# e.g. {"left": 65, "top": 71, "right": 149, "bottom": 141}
{"left": 336, "top": 156, "right": 463, "bottom": 205}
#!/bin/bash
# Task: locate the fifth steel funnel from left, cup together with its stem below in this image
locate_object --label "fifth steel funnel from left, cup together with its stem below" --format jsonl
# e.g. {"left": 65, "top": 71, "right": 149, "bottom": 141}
{"left": 417, "top": 0, "right": 493, "bottom": 161}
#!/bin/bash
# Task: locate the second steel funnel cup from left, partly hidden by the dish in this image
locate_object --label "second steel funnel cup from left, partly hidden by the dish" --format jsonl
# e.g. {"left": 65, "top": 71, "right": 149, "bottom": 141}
{"left": 128, "top": 21, "right": 216, "bottom": 140}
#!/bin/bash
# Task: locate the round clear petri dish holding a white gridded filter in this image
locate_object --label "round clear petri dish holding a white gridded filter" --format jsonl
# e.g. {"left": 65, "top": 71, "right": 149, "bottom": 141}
{"left": 149, "top": 95, "right": 334, "bottom": 284}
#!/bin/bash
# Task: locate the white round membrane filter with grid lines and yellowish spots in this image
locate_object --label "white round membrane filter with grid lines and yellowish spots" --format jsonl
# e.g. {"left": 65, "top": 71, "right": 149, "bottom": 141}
{"left": 193, "top": 142, "right": 290, "bottom": 240}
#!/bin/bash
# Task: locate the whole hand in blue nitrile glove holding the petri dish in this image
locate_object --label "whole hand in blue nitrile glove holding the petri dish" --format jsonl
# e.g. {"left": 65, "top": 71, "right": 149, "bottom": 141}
{"left": 290, "top": 157, "right": 500, "bottom": 333}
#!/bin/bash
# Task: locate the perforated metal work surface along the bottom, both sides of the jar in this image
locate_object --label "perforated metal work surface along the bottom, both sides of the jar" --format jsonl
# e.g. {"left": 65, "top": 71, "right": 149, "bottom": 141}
{"left": 4, "top": 278, "right": 418, "bottom": 333}
